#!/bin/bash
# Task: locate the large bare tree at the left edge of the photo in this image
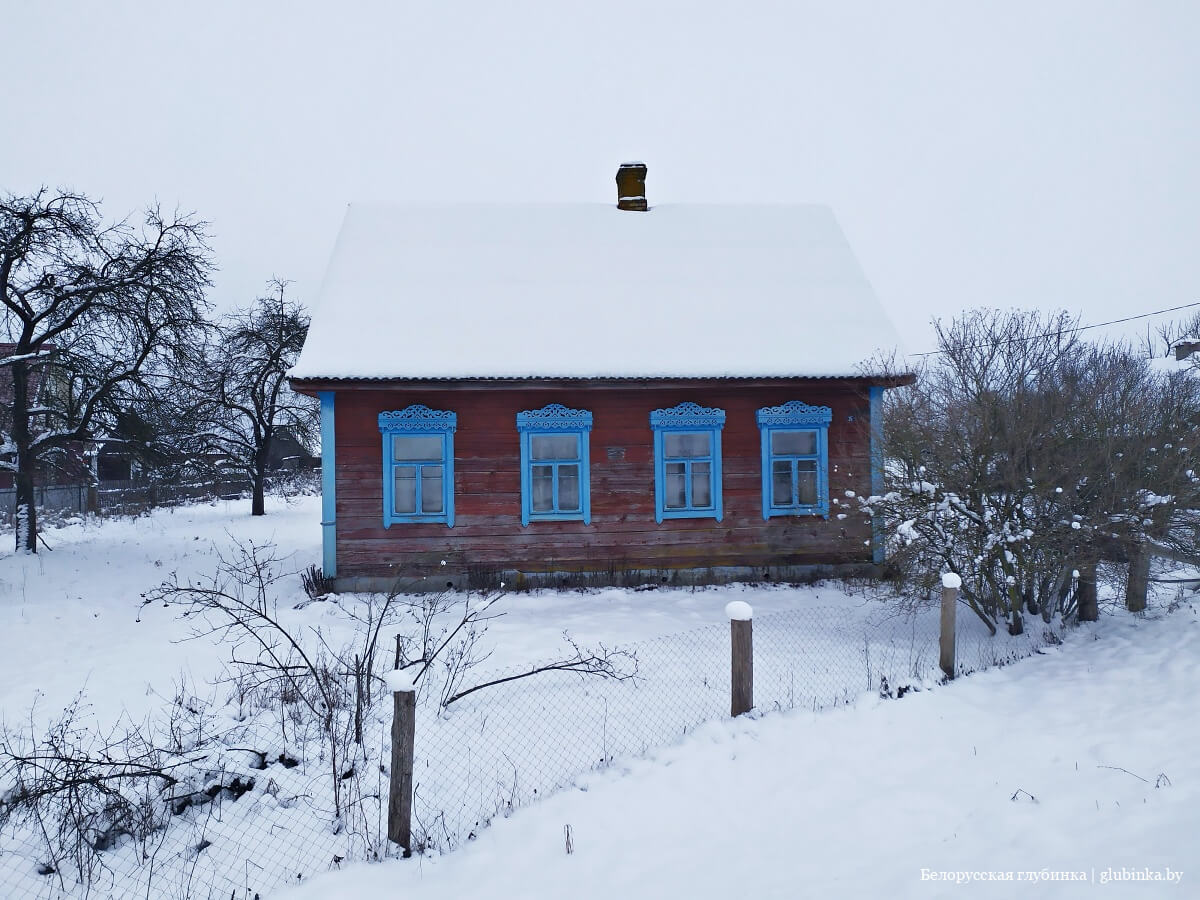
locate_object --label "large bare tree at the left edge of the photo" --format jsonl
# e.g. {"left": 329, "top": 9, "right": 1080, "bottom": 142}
{"left": 0, "top": 188, "right": 211, "bottom": 552}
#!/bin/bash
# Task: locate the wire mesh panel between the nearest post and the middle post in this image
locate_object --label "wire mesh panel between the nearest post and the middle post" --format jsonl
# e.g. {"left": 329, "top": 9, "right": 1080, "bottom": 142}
{"left": 413, "top": 626, "right": 730, "bottom": 850}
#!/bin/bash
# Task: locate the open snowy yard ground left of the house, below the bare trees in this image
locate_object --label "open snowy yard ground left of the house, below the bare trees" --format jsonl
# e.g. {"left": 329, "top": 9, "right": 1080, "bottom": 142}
{"left": 0, "top": 497, "right": 320, "bottom": 725}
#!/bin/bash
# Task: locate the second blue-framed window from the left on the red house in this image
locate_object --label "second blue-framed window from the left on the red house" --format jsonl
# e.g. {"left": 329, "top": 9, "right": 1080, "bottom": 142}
{"left": 517, "top": 403, "right": 592, "bottom": 526}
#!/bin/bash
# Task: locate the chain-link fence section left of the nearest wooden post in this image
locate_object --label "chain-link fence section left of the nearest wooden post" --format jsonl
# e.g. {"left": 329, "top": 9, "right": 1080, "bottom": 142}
{"left": 0, "top": 686, "right": 390, "bottom": 900}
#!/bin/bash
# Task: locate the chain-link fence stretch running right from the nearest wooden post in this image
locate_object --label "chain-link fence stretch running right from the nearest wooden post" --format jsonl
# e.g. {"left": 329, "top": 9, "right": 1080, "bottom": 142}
{"left": 414, "top": 606, "right": 1060, "bottom": 850}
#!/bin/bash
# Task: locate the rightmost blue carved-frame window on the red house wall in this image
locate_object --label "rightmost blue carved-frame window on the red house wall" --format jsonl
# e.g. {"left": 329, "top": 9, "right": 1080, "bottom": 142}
{"left": 756, "top": 400, "right": 833, "bottom": 518}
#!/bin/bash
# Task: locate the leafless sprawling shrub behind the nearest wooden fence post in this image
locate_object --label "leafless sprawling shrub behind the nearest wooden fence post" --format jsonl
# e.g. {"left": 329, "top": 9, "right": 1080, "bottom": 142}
{"left": 142, "top": 542, "right": 637, "bottom": 815}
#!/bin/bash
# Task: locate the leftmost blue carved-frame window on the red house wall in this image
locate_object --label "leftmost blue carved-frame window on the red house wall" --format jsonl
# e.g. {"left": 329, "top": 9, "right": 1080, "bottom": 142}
{"left": 379, "top": 403, "right": 458, "bottom": 528}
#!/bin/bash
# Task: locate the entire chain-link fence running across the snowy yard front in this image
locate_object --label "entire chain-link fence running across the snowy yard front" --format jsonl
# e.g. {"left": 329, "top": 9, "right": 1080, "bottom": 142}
{"left": 0, "top": 595, "right": 1060, "bottom": 900}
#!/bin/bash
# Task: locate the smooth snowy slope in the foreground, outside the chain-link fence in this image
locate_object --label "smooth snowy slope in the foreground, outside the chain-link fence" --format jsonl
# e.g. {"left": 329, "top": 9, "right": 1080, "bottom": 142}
{"left": 274, "top": 606, "right": 1200, "bottom": 900}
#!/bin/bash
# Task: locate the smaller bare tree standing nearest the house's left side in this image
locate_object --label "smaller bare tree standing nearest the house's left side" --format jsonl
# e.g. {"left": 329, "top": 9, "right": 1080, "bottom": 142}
{"left": 196, "top": 280, "right": 319, "bottom": 516}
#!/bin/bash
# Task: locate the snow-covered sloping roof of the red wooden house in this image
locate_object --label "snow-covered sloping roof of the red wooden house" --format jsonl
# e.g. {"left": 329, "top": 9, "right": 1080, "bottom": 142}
{"left": 292, "top": 204, "right": 899, "bottom": 380}
